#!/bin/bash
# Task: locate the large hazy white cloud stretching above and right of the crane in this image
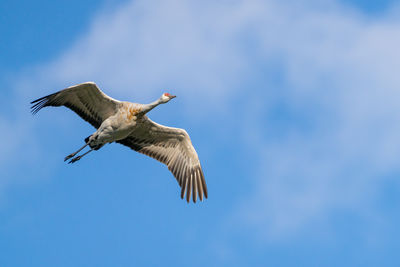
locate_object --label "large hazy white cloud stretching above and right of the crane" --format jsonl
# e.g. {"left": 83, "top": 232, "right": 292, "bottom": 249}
{"left": 7, "top": 0, "right": 400, "bottom": 242}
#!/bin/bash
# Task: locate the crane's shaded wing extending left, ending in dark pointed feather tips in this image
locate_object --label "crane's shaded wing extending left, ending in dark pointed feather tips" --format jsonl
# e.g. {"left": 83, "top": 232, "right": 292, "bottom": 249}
{"left": 31, "top": 82, "right": 120, "bottom": 129}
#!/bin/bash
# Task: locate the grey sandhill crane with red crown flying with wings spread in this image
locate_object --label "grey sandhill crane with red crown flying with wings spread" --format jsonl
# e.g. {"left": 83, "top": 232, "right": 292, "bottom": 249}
{"left": 31, "top": 82, "right": 207, "bottom": 202}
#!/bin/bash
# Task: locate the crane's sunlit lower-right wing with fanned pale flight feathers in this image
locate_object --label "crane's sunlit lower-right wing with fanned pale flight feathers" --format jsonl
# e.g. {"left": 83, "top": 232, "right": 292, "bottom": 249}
{"left": 117, "top": 116, "right": 208, "bottom": 202}
